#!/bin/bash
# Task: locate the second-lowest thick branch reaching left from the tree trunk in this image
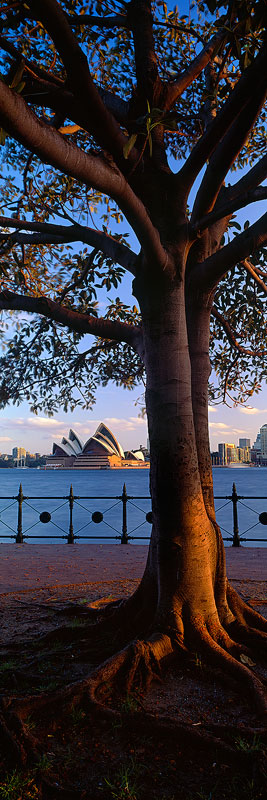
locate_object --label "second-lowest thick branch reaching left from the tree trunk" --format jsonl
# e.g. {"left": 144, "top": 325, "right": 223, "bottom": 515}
{"left": 0, "top": 216, "right": 137, "bottom": 275}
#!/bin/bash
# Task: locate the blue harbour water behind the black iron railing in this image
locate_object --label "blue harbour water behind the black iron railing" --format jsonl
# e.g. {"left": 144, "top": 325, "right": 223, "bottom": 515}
{"left": 0, "top": 467, "right": 267, "bottom": 547}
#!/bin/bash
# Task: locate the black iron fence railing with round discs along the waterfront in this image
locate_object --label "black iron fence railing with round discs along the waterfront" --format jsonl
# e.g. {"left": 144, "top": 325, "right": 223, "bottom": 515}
{"left": 0, "top": 483, "right": 267, "bottom": 547}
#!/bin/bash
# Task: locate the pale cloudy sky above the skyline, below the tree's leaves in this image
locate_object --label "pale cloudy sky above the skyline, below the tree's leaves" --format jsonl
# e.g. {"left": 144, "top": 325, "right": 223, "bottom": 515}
{"left": 0, "top": 0, "right": 267, "bottom": 454}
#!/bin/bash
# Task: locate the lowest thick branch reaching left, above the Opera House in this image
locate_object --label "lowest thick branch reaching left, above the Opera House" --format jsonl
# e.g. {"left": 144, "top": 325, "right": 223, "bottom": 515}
{"left": 0, "top": 290, "right": 142, "bottom": 349}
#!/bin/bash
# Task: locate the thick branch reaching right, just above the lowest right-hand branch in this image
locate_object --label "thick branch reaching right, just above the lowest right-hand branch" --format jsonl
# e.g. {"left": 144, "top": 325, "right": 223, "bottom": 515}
{"left": 192, "top": 186, "right": 267, "bottom": 235}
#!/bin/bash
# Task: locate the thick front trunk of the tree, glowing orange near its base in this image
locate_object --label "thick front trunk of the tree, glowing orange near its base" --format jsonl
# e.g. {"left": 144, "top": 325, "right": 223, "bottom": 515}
{"left": 135, "top": 283, "right": 223, "bottom": 627}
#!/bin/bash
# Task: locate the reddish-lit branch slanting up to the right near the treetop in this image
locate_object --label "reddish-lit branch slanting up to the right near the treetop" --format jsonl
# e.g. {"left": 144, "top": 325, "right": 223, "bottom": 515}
{"left": 165, "top": 30, "right": 225, "bottom": 110}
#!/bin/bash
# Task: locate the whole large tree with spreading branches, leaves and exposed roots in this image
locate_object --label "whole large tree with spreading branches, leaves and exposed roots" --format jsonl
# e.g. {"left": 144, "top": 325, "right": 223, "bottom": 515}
{"left": 0, "top": 0, "right": 267, "bottom": 728}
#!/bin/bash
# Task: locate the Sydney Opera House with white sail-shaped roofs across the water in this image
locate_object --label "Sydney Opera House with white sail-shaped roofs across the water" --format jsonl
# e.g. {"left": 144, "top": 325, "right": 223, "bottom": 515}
{"left": 46, "top": 422, "right": 149, "bottom": 469}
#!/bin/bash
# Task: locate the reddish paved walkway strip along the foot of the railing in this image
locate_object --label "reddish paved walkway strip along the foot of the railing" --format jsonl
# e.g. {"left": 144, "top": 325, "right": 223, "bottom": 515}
{"left": 0, "top": 543, "right": 267, "bottom": 595}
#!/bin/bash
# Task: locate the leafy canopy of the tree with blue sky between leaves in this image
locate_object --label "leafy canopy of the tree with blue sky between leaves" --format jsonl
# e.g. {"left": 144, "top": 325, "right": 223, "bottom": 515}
{"left": 0, "top": 0, "right": 267, "bottom": 414}
